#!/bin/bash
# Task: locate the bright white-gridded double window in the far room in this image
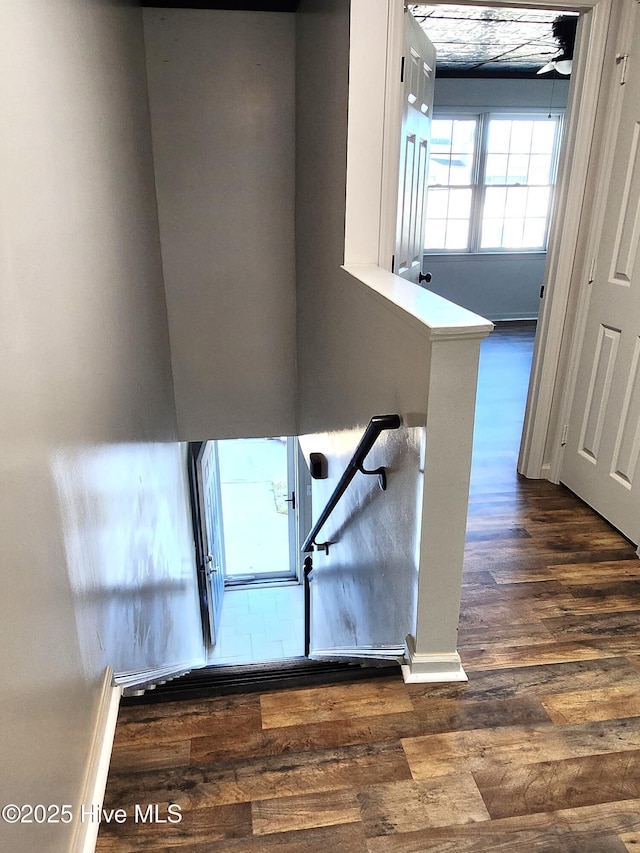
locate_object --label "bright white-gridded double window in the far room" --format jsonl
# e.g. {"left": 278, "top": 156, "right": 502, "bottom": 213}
{"left": 425, "top": 113, "right": 562, "bottom": 252}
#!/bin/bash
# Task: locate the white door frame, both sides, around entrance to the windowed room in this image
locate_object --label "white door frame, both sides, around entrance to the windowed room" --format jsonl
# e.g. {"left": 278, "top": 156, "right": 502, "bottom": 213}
{"left": 345, "top": 0, "right": 621, "bottom": 479}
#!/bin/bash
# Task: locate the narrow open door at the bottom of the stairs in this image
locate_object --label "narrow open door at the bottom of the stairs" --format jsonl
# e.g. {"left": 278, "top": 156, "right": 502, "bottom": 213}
{"left": 198, "top": 441, "right": 224, "bottom": 645}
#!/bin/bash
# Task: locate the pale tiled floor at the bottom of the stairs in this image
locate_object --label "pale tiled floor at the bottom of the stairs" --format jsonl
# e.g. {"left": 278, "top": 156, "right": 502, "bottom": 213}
{"left": 209, "top": 584, "right": 304, "bottom": 666}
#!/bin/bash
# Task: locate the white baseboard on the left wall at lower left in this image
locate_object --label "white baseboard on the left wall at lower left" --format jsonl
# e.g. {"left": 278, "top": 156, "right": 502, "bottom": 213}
{"left": 71, "top": 666, "right": 122, "bottom": 853}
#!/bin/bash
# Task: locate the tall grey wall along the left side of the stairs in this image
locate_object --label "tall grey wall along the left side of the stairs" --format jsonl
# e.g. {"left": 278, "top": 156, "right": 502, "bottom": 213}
{"left": 0, "top": 0, "right": 202, "bottom": 853}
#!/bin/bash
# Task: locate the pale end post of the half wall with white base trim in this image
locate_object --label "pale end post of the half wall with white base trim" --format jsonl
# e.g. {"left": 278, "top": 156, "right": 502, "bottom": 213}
{"left": 403, "top": 326, "right": 490, "bottom": 682}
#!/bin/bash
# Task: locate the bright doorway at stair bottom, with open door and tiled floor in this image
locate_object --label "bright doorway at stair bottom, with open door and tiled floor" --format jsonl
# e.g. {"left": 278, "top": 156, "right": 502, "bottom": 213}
{"left": 191, "top": 436, "right": 311, "bottom": 666}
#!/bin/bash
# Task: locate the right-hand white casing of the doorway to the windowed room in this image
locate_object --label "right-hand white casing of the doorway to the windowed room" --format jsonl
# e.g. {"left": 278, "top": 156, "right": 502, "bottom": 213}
{"left": 508, "top": 0, "right": 615, "bottom": 482}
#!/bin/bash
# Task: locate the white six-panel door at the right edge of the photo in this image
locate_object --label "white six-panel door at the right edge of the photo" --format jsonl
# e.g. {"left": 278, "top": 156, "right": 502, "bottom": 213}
{"left": 560, "top": 4, "right": 640, "bottom": 544}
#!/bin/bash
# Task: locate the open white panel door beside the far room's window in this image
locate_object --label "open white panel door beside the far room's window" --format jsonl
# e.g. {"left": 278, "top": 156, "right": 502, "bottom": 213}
{"left": 394, "top": 10, "right": 436, "bottom": 283}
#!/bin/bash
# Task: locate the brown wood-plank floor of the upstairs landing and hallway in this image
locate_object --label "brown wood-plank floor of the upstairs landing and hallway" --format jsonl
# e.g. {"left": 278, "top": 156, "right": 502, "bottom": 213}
{"left": 97, "top": 322, "right": 640, "bottom": 853}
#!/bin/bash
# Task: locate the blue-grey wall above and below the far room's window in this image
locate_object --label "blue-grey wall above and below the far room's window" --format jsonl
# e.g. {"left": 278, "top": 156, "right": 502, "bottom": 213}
{"left": 423, "top": 77, "right": 569, "bottom": 320}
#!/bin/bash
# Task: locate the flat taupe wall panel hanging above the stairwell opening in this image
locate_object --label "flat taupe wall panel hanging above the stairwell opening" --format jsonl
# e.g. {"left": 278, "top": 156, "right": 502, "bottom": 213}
{"left": 144, "top": 9, "right": 296, "bottom": 440}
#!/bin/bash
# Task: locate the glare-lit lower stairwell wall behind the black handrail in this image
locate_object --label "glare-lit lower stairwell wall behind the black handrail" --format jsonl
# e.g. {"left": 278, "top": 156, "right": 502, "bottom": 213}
{"left": 302, "top": 424, "right": 424, "bottom": 651}
